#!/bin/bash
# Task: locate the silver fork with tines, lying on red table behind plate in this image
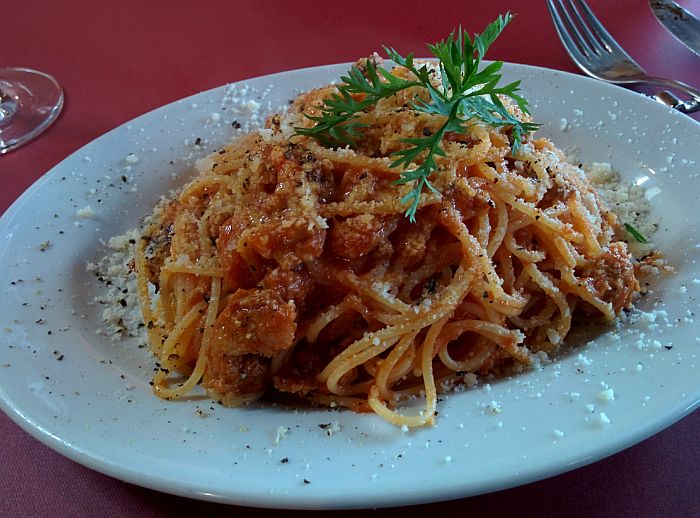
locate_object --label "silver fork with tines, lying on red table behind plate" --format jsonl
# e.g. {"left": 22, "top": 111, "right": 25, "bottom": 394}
{"left": 547, "top": 0, "right": 700, "bottom": 113}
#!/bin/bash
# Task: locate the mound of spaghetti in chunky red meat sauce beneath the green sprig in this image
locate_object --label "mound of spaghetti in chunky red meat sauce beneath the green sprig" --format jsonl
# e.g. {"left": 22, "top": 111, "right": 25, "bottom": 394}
{"left": 136, "top": 59, "right": 639, "bottom": 426}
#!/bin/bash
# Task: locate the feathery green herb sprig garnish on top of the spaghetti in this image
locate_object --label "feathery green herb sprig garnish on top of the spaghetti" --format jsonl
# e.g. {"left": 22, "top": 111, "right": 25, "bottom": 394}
{"left": 295, "top": 13, "right": 538, "bottom": 222}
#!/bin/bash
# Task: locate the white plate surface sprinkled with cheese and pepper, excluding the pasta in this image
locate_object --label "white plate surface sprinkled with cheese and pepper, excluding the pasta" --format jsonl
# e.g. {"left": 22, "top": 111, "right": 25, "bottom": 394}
{"left": 0, "top": 65, "right": 700, "bottom": 508}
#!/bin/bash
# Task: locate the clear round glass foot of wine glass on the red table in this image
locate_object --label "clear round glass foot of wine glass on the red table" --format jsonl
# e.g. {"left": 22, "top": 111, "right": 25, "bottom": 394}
{"left": 0, "top": 67, "right": 63, "bottom": 155}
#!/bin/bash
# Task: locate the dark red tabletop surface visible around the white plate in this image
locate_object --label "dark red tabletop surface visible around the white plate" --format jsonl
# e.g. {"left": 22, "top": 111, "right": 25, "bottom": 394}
{"left": 0, "top": 0, "right": 700, "bottom": 518}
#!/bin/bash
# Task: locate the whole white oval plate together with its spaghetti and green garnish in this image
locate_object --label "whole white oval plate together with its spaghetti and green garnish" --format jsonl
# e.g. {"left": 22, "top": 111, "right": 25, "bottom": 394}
{"left": 0, "top": 20, "right": 700, "bottom": 508}
